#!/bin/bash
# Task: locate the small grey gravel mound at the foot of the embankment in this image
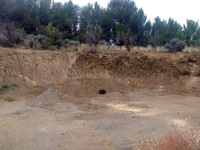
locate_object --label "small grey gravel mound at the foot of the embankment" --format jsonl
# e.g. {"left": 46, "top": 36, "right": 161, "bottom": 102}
{"left": 27, "top": 88, "right": 62, "bottom": 108}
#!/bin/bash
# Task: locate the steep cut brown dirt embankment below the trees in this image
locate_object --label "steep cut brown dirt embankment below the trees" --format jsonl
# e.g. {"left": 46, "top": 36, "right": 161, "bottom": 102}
{"left": 0, "top": 48, "right": 200, "bottom": 95}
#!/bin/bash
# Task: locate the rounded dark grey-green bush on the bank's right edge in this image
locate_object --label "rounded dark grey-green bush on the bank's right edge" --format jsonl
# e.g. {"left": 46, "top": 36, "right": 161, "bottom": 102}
{"left": 164, "top": 38, "right": 186, "bottom": 53}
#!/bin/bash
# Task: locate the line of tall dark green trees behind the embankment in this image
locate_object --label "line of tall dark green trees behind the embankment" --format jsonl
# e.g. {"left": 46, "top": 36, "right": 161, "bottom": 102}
{"left": 0, "top": 0, "right": 200, "bottom": 49}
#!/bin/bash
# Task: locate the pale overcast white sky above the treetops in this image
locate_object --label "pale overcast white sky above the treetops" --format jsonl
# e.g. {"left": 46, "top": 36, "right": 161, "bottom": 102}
{"left": 55, "top": 0, "right": 200, "bottom": 25}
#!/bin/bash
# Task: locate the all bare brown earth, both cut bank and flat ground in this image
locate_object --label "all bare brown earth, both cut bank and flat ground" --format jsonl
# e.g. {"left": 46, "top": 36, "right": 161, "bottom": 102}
{"left": 0, "top": 48, "right": 200, "bottom": 150}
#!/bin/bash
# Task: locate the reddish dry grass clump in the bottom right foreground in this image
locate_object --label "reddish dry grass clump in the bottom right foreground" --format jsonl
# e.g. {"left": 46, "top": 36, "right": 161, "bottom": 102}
{"left": 137, "top": 126, "right": 200, "bottom": 150}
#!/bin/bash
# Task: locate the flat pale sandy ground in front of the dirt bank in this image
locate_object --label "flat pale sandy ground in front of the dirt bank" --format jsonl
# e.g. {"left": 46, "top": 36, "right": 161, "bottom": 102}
{"left": 0, "top": 90, "right": 200, "bottom": 150}
